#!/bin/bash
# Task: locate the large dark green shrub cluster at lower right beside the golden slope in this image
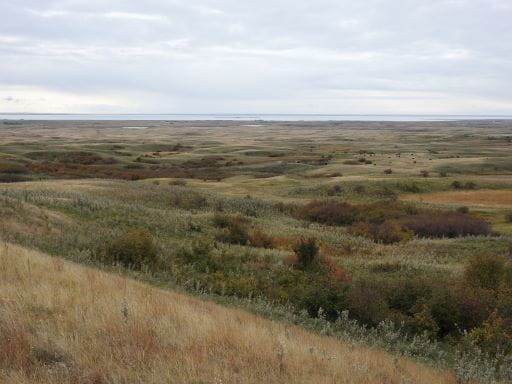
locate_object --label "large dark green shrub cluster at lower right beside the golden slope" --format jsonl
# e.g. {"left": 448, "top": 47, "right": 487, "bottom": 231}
{"left": 343, "top": 255, "right": 512, "bottom": 354}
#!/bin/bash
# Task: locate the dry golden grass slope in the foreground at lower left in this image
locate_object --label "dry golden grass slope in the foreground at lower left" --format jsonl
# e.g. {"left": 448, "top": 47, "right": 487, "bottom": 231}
{"left": 0, "top": 244, "right": 454, "bottom": 384}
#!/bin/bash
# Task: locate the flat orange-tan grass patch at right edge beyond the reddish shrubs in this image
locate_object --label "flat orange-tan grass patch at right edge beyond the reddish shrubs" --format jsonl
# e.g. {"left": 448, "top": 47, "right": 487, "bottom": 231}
{"left": 402, "top": 189, "right": 512, "bottom": 207}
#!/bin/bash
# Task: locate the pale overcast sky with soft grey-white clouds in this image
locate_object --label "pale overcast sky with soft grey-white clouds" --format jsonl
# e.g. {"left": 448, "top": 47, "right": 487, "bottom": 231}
{"left": 0, "top": 0, "right": 512, "bottom": 115}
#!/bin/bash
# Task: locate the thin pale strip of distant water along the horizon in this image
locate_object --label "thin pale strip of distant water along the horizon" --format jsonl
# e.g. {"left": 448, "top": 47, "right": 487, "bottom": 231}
{"left": 0, "top": 113, "right": 512, "bottom": 121}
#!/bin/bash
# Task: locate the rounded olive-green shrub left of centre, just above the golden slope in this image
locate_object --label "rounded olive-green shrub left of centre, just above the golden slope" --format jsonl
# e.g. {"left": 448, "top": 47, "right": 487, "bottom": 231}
{"left": 107, "top": 229, "right": 157, "bottom": 269}
